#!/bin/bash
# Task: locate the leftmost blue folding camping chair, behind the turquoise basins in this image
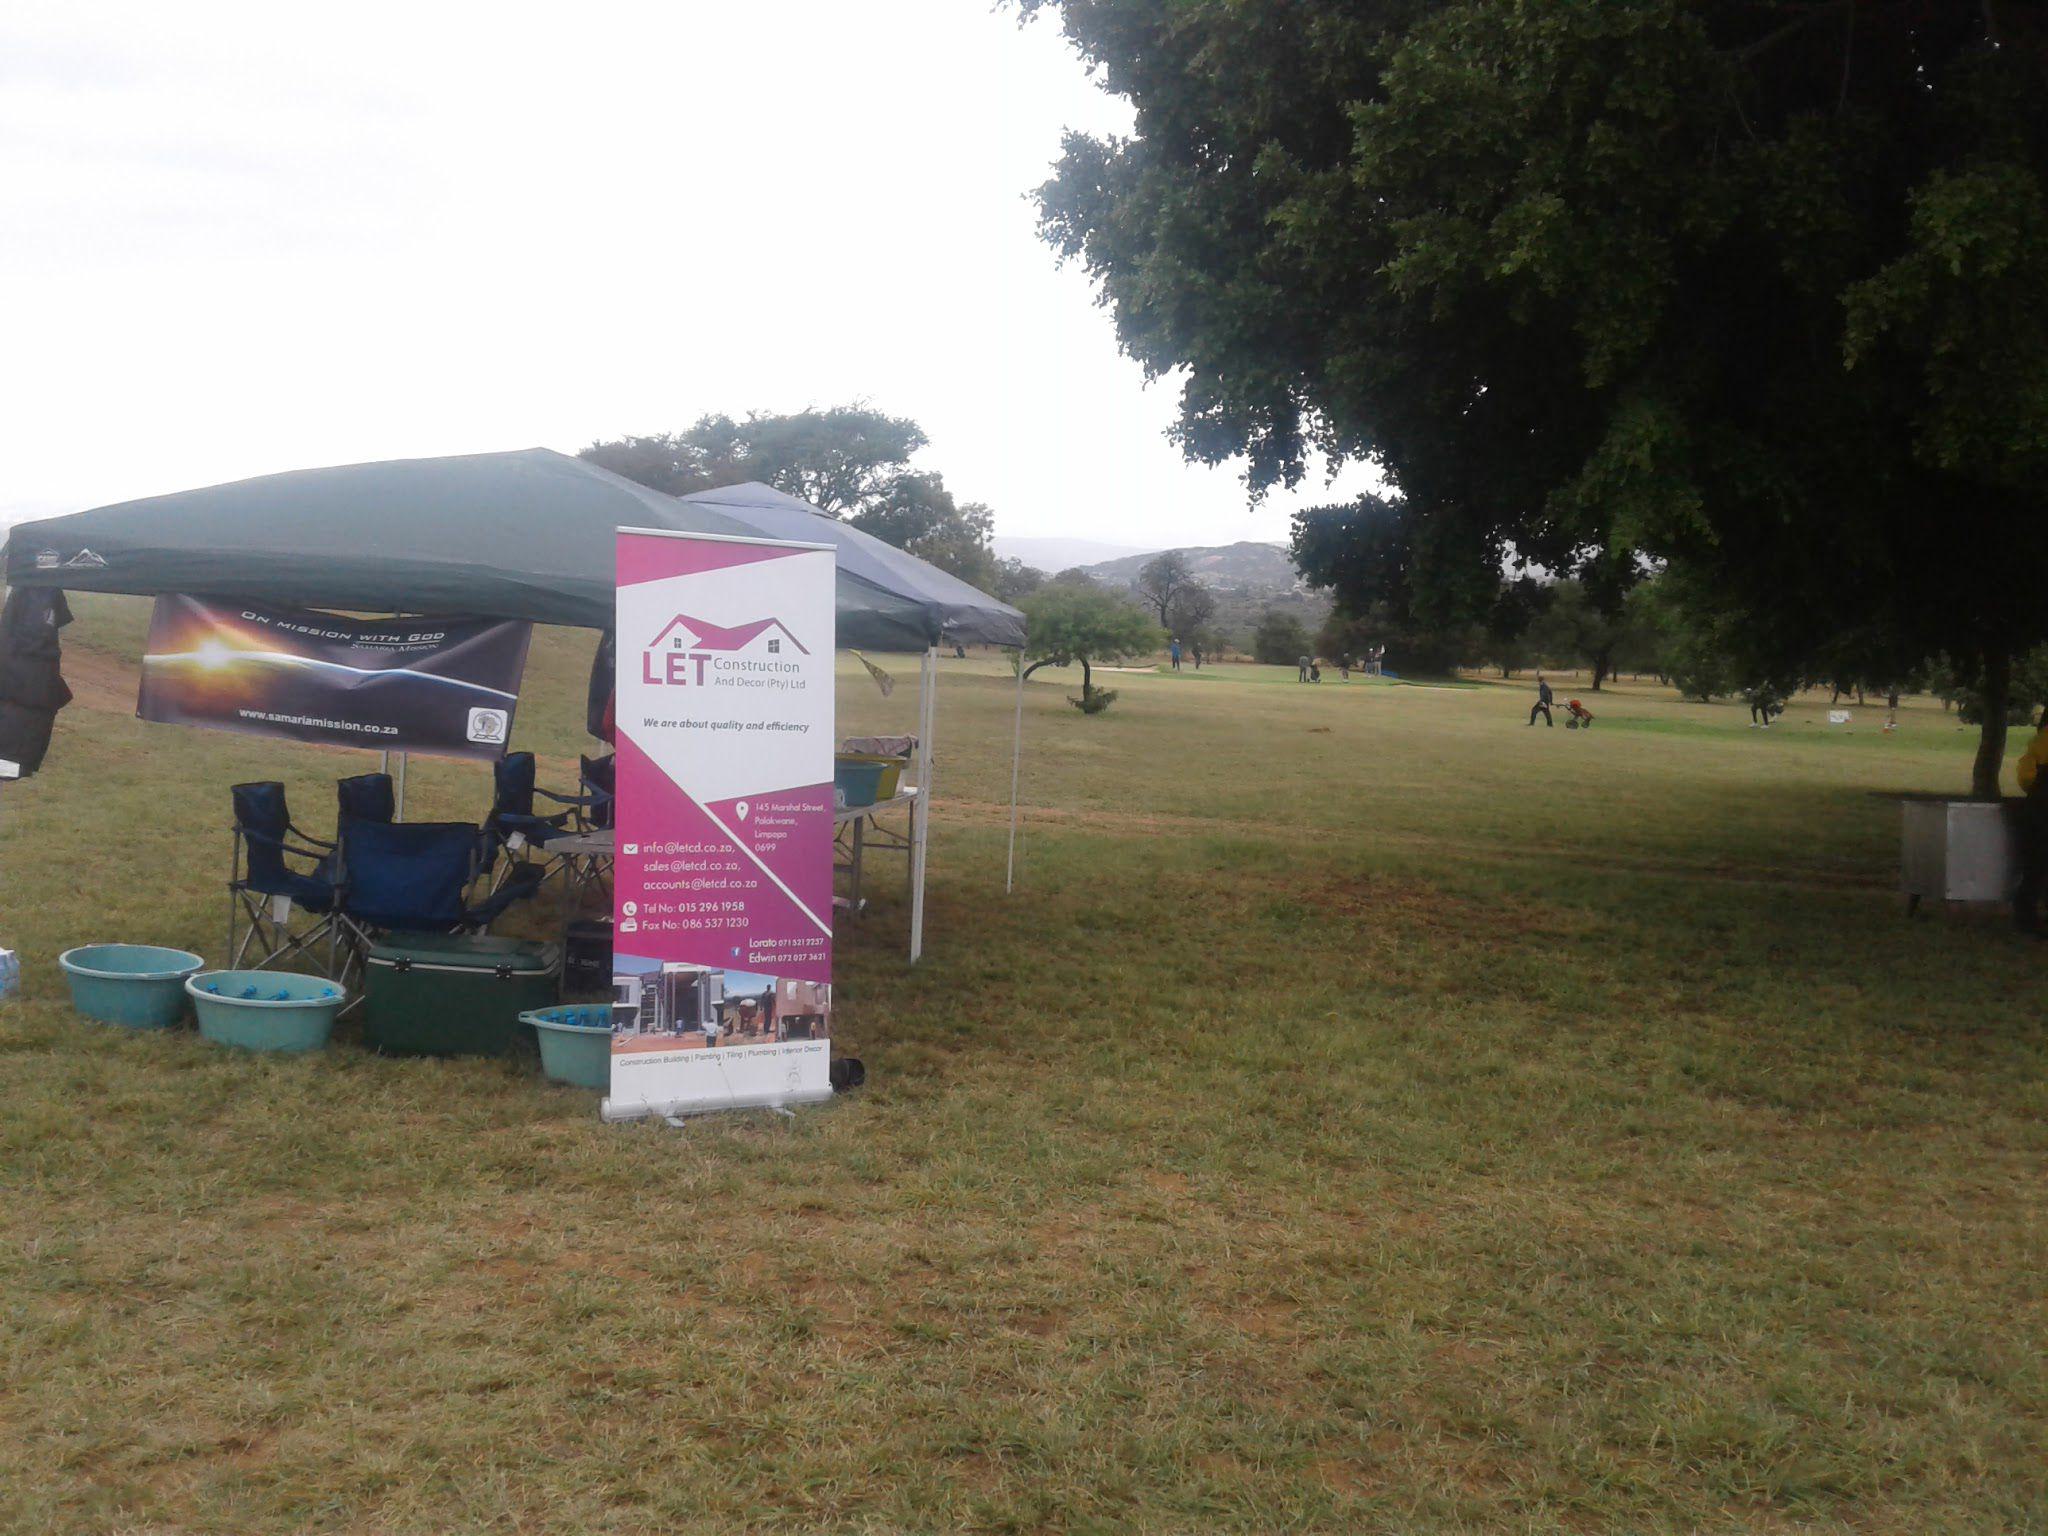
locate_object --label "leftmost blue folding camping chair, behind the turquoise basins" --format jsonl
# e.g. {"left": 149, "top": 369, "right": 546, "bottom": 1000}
{"left": 227, "top": 778, "right": 340, "bottom": 977}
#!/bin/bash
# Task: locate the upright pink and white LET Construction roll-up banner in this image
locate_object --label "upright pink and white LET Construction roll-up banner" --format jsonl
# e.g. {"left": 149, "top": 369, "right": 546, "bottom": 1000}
{"left": 604, "top": 528, "right": 836, "bottom": 1120}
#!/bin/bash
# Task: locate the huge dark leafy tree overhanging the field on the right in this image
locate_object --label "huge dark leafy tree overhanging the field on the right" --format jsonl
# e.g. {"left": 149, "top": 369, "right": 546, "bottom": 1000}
{"left": 1018, "top": 0, "right": 2048, "bottom": 793}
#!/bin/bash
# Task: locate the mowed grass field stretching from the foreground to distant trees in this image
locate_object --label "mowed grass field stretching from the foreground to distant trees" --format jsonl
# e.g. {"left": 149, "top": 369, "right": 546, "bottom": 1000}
{"left": 0, "top": 600, "right": 2048, "bottom": 1536}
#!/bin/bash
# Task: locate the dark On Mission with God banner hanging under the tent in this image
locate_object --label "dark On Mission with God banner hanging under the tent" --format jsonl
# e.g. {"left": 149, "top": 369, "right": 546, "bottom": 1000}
{"left": 135, "top": 596, "right": 532, "bottom": 758}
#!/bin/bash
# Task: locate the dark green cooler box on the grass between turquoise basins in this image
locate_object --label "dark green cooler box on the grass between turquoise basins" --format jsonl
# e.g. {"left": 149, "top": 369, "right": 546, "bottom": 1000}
{"left": 362, "top": 934, "right": 561, "bottom": 1057}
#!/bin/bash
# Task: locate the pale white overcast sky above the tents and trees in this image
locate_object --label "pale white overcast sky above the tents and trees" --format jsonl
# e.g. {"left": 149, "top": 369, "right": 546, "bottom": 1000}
{"left": 0, "top": 0, "right": 1376, "bottom": 547}
